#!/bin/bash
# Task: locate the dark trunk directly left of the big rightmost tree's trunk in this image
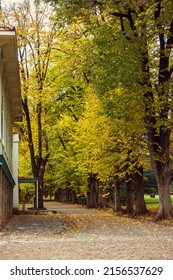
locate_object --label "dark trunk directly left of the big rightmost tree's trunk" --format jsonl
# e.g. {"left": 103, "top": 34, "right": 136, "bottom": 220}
{"left": 133, "top": 167, "right": 148, "bottom": 215}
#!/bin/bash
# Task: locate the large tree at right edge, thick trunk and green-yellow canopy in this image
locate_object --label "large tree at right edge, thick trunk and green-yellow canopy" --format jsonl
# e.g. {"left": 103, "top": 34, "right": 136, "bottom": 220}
{"left": 46, "top": 0, "right": 173, "bottom": 219}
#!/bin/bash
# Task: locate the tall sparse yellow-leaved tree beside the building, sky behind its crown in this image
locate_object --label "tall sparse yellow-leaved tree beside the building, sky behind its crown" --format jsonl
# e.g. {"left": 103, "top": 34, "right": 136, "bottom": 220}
{"left": 4, "top": 0, "right": 57, "bottom": 208}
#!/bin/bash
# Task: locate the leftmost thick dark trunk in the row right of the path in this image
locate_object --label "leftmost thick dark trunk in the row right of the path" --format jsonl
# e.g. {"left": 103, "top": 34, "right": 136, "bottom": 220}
{"left": 87, "top": 174, "right": 97, "bottom": 208}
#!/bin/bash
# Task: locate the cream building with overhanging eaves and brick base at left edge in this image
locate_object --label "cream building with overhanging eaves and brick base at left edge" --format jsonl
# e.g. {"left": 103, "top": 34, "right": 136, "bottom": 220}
{"left": 0, "top": 26, "right": 22, "bottom": 226}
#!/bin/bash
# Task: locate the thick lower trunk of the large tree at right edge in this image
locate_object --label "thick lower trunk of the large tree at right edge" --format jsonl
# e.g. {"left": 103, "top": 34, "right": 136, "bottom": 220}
{"left": 148, "top": 128, "right": 173, "bottom": 221}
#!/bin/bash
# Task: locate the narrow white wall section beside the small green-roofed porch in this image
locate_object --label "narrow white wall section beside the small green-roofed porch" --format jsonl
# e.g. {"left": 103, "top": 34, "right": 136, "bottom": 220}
{"left": 13, "top": 133, "right": 19, "bottom": 208}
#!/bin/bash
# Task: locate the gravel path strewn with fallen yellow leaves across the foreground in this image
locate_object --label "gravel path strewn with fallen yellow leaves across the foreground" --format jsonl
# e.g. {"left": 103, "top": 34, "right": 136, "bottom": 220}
{"left": 0, "top": 202, "right": 173, "bottom": 260}
